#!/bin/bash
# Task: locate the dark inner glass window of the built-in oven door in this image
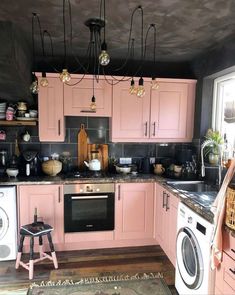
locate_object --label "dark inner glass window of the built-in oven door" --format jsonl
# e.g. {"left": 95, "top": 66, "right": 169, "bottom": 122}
{"left": 72, "top": 199, "right": 107, "bottom": 221}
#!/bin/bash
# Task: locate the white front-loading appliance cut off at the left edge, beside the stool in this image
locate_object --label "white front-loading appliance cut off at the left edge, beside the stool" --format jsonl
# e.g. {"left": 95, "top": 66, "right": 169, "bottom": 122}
{"left": 0, "top": 186, "right": 17, "bottom": 261}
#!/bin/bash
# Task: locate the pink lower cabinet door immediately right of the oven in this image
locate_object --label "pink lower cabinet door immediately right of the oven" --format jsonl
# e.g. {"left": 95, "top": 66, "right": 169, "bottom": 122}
{"left": 115, "top": 183, "right": 154, "bottom": 240}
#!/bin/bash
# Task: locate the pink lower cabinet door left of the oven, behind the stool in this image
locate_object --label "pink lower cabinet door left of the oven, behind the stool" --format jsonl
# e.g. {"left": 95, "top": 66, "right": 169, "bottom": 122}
{"left": 19, "top": 185, "right": 64, "bottom": 244}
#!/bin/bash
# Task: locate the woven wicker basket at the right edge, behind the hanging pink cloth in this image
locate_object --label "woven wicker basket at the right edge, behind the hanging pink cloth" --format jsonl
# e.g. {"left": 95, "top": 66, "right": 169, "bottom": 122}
{"left": 225, "top": 187, "right": 235, "bottom": 230}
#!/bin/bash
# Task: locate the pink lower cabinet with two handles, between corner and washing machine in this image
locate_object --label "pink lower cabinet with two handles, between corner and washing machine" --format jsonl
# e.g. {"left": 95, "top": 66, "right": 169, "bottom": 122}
{"left": 155, "top": 184, "right": 179, "bottom": 266}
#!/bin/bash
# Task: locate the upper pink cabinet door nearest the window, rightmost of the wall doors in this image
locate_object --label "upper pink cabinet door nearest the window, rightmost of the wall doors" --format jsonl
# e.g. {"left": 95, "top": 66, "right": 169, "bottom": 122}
{"left": 150, "top": 82, "right": 188, "bottom": 139}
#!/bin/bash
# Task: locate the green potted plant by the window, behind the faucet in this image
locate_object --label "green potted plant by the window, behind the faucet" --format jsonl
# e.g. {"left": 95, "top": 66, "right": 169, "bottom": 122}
{"left": 204, "top": 129, "right": 223, "bottom": 165}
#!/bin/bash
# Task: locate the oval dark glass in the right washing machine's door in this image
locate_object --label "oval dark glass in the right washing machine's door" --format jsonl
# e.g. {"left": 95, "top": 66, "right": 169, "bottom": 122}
{"left": 182, "top": 237, "right": 196, "bottom": 277}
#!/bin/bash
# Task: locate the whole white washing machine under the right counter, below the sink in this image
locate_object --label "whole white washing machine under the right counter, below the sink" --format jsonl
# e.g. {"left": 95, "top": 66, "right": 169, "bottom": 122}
{"left": 175, "top": 203, "right": 215, "bottom": 295}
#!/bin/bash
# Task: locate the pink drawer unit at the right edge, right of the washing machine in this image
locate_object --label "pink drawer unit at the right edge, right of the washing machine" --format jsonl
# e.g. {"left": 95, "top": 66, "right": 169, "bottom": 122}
{"left": 215, "top": 231, "right": 235, "bottom": 295}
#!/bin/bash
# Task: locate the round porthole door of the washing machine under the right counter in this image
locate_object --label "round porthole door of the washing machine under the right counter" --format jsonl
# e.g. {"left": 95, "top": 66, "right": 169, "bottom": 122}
{"left": 176, "top": 227, "right": 204, "bottom": 289}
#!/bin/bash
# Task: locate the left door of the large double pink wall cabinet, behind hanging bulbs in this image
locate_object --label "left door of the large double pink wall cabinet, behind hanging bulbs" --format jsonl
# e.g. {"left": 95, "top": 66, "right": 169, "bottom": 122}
{"left": 111, "top": 81, "right": 150, "bottom": 141}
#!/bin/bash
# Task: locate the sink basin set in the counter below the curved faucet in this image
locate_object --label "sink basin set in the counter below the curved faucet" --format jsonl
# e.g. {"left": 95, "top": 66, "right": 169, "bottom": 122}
{"left": 167, "top": 181, "right": 217, "bottom": 192}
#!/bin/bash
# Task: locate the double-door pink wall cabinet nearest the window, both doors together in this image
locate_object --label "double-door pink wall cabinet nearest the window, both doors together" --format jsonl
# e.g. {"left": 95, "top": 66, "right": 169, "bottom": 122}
{"left": 110, "top": 79, "right": 196, "bottom": 142}
